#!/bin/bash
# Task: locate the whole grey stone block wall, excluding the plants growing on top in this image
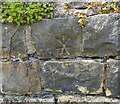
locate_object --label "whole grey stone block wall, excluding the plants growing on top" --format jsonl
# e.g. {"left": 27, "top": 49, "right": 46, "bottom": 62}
{"left": 0, "top": 2, "right": 120, "bottom": 104}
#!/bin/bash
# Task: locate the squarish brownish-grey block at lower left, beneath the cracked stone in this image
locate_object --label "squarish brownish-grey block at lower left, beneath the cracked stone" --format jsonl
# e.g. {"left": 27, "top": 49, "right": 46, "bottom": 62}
{"left": 0, "top": 61, "right": 41, "bottom": 94}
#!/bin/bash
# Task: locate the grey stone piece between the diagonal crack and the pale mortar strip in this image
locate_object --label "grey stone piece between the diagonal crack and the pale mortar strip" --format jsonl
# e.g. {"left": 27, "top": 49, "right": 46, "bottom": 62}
{"left": 10, "top": 26, "right": 27, "bottom": 57}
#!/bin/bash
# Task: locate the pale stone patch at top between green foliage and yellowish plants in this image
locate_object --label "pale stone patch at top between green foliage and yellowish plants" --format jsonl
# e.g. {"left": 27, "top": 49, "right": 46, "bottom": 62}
{"left": 53, "top": 1, "right": 88, "bottom": 18}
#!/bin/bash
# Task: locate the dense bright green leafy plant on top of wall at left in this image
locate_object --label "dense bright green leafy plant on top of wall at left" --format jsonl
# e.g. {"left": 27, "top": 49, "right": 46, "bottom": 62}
{"left": 0, "top": 2, "right": 54, "bottom": 25}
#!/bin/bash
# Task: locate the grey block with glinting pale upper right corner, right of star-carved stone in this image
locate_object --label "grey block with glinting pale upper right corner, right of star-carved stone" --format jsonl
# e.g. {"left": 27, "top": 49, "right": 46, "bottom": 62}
{"left": 83, "top": 14, "right": 120, "bottom": 57}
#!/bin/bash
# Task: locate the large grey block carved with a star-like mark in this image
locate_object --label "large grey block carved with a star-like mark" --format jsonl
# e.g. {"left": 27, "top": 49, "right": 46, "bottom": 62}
{"left": 32, "top": 17, "right": 82, "bottom": 58}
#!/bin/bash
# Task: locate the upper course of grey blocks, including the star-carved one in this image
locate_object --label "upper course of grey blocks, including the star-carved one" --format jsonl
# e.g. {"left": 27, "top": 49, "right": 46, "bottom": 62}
{"left": 2, "top": 14, "right": 120, "bottom": 59}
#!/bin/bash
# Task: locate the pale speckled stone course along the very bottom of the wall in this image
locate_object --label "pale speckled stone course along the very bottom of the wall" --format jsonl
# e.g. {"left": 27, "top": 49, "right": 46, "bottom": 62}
{"left": 0, "top": 95, "right": 119, "bottom": 104}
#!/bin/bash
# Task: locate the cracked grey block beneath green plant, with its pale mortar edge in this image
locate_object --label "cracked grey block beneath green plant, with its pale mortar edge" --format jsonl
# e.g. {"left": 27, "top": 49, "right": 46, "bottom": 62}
{"left": 1, "top": 23, "right": 36, "bottom": 60}
